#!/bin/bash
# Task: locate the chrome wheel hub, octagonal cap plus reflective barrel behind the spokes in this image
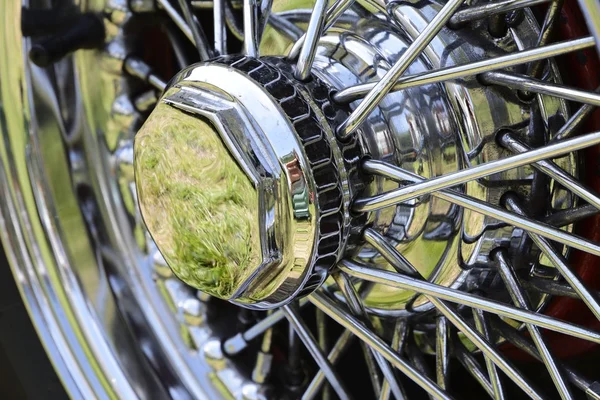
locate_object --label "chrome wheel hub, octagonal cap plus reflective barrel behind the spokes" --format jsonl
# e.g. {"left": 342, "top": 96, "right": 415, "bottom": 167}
{"left": 135, "top": 2, "right": 576, "bottom": 315}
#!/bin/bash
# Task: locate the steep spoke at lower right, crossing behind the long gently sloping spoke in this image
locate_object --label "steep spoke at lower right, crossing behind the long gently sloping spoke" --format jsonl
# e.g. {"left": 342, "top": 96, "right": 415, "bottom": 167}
{"left": 494, "top": 250, "right": 573, "bottom": 399}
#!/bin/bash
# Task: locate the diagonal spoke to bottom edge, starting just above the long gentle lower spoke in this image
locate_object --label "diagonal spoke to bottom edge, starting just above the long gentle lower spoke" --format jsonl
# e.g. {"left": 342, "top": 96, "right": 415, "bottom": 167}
{"left": 360, "top": 228, "right": 543, "bottom": 399}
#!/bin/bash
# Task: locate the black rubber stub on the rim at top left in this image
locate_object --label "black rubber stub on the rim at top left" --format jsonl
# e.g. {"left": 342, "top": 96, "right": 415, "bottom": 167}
{"left": 29, "top": 14, "right": 105, "bottom": 67}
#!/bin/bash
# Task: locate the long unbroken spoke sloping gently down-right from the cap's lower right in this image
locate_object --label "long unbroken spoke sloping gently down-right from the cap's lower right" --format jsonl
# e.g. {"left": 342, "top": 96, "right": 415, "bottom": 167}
{"left": 340, "top": 260, "right": 600, "bottom": 343}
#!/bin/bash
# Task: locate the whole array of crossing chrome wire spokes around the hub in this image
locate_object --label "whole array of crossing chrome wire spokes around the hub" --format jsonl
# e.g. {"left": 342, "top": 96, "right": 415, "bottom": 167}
{"left": 134, "top": 0, "right": 600, "bottom": 399}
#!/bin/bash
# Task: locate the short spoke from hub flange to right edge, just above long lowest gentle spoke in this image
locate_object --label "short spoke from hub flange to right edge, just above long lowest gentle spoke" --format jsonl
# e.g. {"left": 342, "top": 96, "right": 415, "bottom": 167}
{"left": 506, "top": 194, "right": 600, "bottom": 320}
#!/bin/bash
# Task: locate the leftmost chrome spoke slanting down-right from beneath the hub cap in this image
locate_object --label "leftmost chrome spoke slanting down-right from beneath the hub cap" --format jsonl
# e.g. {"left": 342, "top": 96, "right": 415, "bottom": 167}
{"left": 281, "top": 305, "right": 350, "bottom": 399}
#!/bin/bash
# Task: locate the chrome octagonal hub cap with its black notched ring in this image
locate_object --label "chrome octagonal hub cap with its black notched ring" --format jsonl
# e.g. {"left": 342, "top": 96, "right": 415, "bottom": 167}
{"left": 134, "top": 58, "right": 347, "bottom": 309}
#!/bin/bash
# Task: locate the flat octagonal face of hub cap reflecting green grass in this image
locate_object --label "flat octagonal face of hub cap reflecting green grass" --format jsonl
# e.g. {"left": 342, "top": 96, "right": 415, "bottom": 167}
{"left": 135, "top": 104, "right": 261, "bottom": 298}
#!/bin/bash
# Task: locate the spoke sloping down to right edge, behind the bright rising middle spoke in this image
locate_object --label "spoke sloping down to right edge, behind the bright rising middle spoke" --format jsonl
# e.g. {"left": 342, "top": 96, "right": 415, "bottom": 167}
{"left": 355, "top": 160, "right": 600, "bottom": 255}
